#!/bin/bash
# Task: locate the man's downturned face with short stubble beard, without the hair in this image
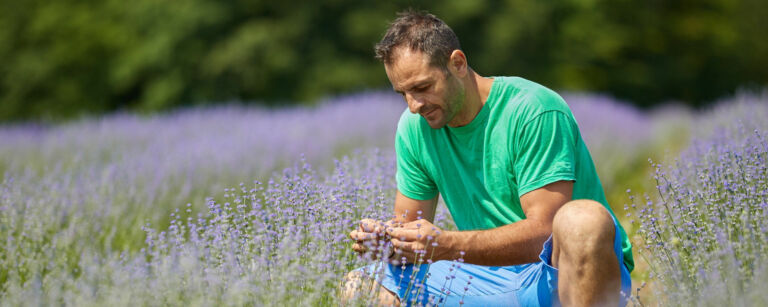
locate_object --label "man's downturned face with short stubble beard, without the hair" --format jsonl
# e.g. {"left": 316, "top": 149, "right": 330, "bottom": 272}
{"left": 384, "top": 48, "right": 464, "bottom": 129}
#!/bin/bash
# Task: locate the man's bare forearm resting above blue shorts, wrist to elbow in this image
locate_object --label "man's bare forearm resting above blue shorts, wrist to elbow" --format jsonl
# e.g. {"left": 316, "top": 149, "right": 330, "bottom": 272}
{"left": 438, "top": 219, "right": 552, "bottom": 266}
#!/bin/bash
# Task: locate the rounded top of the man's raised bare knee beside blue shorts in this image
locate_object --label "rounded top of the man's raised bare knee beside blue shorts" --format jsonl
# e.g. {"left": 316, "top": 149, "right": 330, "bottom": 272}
{"left": 552, "top": 200, "right": 615, "bottom": 254}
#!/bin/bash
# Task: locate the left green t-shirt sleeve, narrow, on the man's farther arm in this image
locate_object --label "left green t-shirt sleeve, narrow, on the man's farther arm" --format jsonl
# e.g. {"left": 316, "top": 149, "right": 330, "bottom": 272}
{"left": 395, "top": 131, "right": 437, "bottom": 200}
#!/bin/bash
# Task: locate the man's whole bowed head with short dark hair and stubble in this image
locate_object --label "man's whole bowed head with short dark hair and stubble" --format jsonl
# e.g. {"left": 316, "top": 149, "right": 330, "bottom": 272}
{"left": 376, "top": 11, "right": 469, "bottom": 129}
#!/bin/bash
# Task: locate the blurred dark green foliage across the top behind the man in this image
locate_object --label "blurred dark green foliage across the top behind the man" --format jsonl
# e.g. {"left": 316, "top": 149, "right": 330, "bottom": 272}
{"left": 0, "top": 0, "right": 768, "bottom": 121}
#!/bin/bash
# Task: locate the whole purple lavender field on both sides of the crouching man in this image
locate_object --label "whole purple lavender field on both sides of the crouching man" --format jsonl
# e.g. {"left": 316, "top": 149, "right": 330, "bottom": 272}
{"left": 0, "top": 92, "right": 768, "bottom": 306}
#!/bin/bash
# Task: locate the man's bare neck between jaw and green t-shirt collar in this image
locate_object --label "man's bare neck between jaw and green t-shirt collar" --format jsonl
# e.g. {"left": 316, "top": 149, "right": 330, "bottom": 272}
{"left": 448, "top": 69, "right": 493, "bottom": 127}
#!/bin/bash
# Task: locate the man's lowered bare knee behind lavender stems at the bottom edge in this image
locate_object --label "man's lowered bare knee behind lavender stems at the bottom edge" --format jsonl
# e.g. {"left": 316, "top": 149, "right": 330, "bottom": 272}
{"left": 341, "top": 271, "right": 400, "bottom": 306}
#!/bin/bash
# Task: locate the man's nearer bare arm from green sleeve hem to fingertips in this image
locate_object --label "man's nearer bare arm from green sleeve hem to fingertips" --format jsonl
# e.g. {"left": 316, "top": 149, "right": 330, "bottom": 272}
{"left": 390, "top": 181, "right": 573, "bottom": 266}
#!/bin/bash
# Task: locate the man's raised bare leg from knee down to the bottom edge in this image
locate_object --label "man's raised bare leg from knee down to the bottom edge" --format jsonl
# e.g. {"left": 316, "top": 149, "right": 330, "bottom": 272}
{"left": 552, "top": 200, "right": 621, "bottom": 306}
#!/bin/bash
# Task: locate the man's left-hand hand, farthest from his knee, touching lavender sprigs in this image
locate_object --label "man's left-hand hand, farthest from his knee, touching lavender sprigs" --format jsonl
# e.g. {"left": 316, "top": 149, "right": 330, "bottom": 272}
{"left": 349, "top": 219, "right": 397, "bottom": 260}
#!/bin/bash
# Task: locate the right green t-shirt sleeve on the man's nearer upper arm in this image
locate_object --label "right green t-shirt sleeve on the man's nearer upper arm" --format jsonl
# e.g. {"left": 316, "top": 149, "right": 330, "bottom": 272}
{"left": 513, "top": 111, "right": 578, "bottom": 196}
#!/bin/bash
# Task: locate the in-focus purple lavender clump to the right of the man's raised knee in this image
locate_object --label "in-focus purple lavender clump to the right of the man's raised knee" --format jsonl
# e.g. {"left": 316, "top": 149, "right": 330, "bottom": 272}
{"left": 627, "top": 96, "right": 768, "bottom": 306}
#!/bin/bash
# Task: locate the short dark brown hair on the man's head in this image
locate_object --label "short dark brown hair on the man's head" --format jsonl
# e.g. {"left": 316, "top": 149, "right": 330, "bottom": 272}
{"left": 375, "top": 10, "right": 461, "bottom": 69}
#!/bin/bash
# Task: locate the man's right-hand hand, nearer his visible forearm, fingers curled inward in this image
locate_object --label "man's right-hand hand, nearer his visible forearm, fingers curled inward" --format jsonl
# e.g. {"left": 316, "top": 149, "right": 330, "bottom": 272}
{"left": 386, "top": 219, "right": 454, "bottom": 263}
